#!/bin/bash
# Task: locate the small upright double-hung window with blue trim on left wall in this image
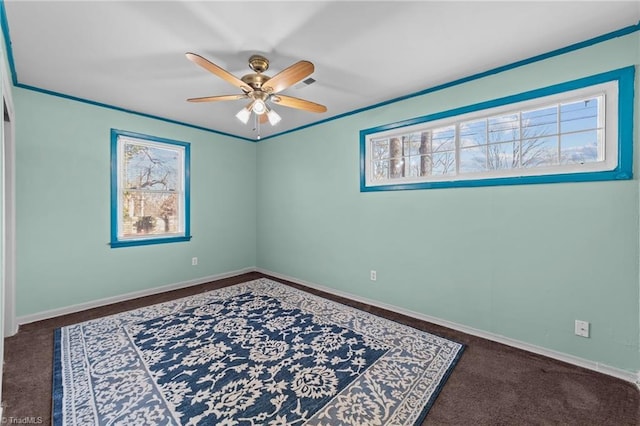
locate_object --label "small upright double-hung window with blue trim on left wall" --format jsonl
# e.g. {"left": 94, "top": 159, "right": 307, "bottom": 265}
{"left": 111, "top": 129, "right": 191, "bottom": 248}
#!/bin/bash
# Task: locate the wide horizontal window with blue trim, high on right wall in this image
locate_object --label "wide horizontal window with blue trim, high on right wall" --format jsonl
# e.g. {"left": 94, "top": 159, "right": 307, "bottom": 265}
{"left": 360, "top": 67, "right": 634, "bottom": 191}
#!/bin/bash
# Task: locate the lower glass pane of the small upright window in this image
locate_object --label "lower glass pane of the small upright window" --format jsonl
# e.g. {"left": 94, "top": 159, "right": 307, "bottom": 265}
{"left": 122, "top": 191, "right": 180, "bottom": 237}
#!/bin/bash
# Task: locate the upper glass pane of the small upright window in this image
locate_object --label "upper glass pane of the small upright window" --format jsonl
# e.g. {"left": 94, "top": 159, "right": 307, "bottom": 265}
{"left": 123, "top": 143, "right": 181, "bottom": 191}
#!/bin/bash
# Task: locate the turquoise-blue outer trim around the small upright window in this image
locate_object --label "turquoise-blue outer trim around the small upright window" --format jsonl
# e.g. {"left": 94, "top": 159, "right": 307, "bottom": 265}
{"left": 109, "top": 129, "right": 191, "bottom": 248}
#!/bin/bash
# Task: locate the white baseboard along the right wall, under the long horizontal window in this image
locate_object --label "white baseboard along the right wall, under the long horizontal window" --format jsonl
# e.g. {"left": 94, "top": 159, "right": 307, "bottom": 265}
{"left": 255, "top": 268, "right": 640, "bottom": 388}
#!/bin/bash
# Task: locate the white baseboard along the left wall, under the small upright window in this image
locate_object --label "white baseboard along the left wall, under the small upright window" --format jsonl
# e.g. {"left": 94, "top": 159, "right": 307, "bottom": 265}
{"left": 16, "top": 267, "right": 256, "bottom": 326}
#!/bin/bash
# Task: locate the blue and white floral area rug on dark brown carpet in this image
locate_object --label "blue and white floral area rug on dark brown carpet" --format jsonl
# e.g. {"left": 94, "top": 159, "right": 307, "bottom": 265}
{"left": 53, "top": 279, "right": 463, "bottom": 426}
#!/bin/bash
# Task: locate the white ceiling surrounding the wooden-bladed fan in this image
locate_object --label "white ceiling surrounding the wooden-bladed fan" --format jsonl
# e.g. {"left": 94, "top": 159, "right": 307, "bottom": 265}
{"left": 4, "top": 0, "right": 640, "bottom": 139}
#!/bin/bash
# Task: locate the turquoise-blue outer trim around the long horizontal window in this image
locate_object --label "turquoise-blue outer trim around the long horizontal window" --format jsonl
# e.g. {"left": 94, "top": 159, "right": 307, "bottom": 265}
{"left": 360, "top": 66, "right": 635, "bottom": 192}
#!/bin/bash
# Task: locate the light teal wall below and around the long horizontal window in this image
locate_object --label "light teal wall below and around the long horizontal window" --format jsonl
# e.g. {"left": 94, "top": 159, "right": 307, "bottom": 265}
{"left": 257, "top": 32, "right": 640, "bottom": 371}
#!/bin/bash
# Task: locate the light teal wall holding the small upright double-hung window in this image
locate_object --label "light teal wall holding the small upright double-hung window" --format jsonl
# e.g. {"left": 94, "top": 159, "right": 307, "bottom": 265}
{"left": 14, "top": 88, "right": 256, "bottom": 317}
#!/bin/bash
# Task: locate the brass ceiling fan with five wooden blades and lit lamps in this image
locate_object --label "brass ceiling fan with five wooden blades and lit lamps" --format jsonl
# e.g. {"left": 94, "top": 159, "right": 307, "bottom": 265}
{"left": 186, "top": 52, "right": 327, "bottom": 131}
